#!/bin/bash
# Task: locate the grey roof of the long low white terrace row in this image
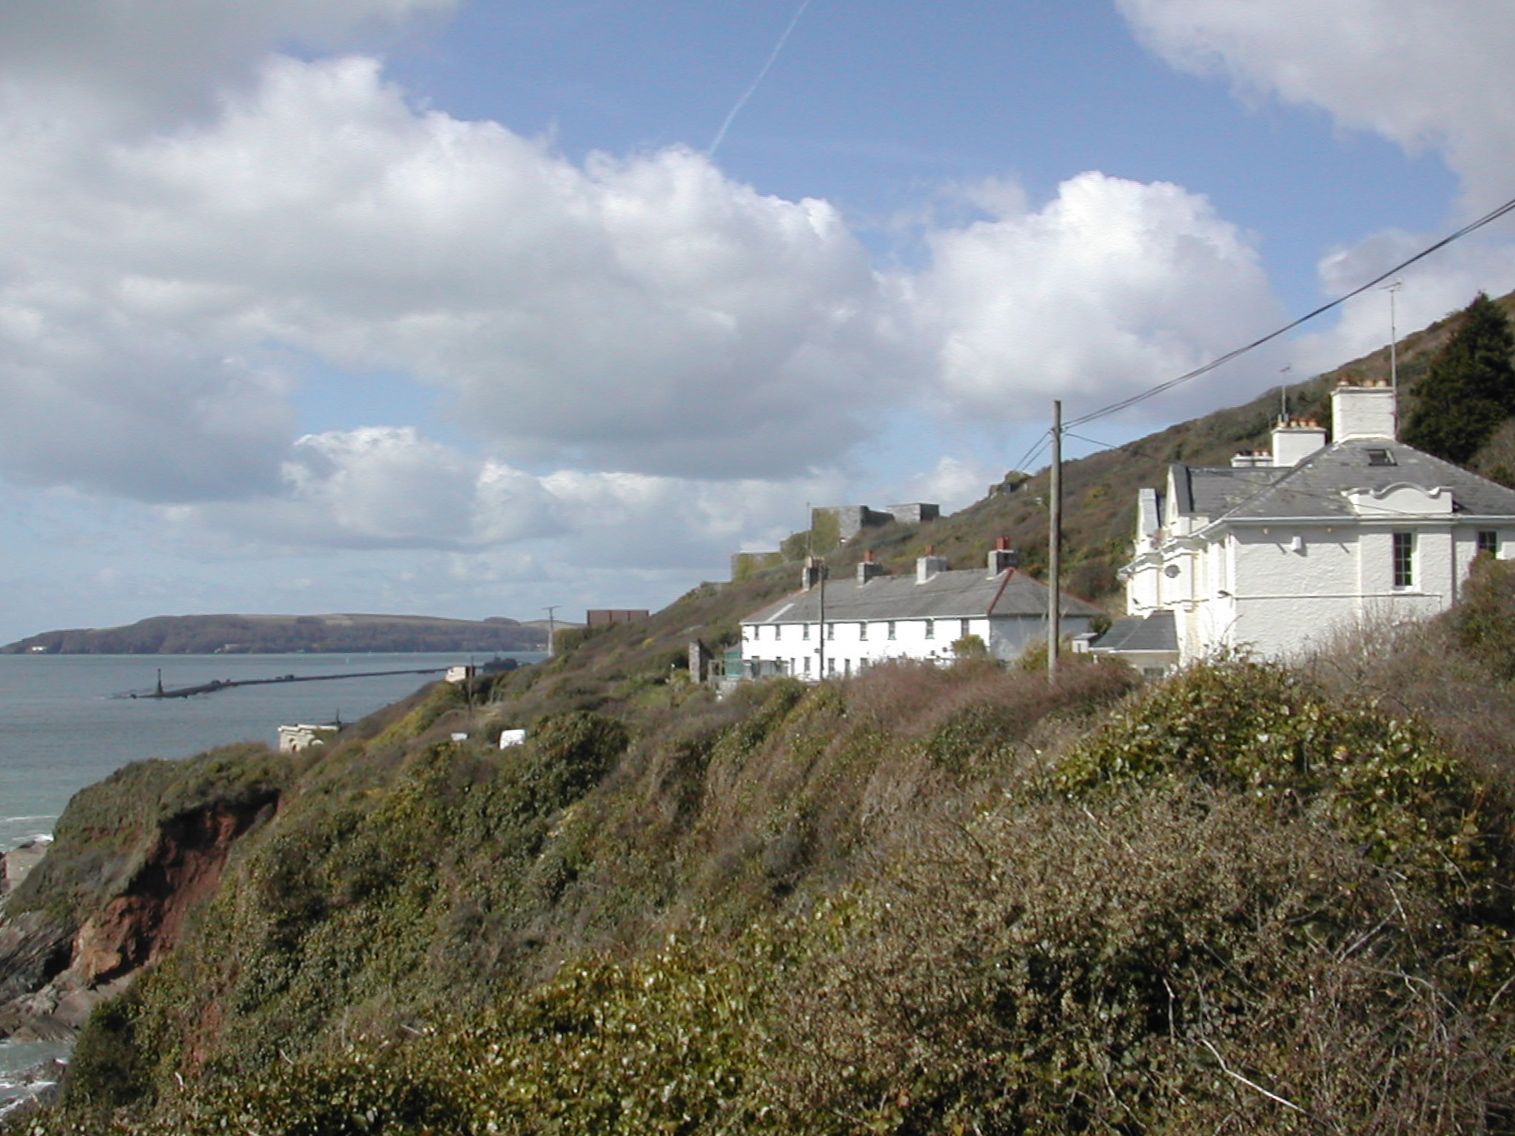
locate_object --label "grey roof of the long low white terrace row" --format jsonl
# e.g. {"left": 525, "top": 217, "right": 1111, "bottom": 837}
{"left": 742, "top": 568, "right": 1101, "bottom": 624}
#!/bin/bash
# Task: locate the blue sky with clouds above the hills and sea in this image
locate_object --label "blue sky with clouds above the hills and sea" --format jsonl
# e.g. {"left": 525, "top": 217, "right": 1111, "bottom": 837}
{"left": 0, "top": 0, "right": 1515, "bottom": 642}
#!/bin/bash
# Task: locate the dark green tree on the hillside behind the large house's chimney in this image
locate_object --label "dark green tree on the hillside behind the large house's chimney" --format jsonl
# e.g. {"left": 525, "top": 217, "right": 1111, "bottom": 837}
{"left": 1404, "top": 292, "right": 1515, "bottom": 465}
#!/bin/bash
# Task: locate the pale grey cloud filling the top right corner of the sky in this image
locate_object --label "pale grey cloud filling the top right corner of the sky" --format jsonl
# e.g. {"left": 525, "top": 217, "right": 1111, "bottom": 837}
{"left": 1118, "top": 0, "right": 1515, "bottom": 212}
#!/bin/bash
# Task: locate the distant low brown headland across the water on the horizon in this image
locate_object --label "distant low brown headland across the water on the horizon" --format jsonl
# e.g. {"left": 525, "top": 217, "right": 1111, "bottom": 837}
{"left": 0, "top": 615, "right": 547, "bottom": 654}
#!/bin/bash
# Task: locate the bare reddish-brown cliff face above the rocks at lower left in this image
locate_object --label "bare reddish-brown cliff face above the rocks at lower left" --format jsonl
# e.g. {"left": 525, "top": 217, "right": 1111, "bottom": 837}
{"left": 71, "top": 797, "right": 277, "bottom": 986}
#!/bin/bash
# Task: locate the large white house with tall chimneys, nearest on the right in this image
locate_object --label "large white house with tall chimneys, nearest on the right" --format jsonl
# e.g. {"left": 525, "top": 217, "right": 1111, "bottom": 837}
{"left": 1091, "top": 383, "right": 1515, "bottom": 673}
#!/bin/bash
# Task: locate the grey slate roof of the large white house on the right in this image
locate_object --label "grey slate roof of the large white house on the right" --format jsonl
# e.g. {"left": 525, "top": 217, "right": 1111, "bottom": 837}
{"left": 1174, "top": 438, "right": 1515, "bottom": 521}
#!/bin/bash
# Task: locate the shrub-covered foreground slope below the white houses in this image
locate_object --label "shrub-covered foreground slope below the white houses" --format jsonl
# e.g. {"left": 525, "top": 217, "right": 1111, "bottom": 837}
{"left": 11, "top": 563, "right": 1515, "bottom": 1134}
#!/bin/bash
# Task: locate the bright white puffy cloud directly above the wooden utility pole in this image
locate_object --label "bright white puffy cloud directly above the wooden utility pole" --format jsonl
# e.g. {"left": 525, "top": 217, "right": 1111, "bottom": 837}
{"left": 917, "top": 173, "right": 1280, "bottom": 420}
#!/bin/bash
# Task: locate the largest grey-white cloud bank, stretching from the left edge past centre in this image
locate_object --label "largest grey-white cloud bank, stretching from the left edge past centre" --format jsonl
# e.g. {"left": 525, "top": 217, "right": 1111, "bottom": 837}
{"left": 0, "top": 49, "right": 915, "bottom": 492}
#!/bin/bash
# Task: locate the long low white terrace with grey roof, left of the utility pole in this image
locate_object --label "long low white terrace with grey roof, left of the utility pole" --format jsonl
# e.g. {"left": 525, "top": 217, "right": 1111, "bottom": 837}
{"left": 742, "top": 539, "right": 1101, "bottom": 680}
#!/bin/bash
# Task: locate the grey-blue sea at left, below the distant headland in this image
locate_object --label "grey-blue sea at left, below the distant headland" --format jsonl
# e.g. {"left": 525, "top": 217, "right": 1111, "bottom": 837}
{"left": 0, "top": 651, "right": 545, "bottom": 1115}
